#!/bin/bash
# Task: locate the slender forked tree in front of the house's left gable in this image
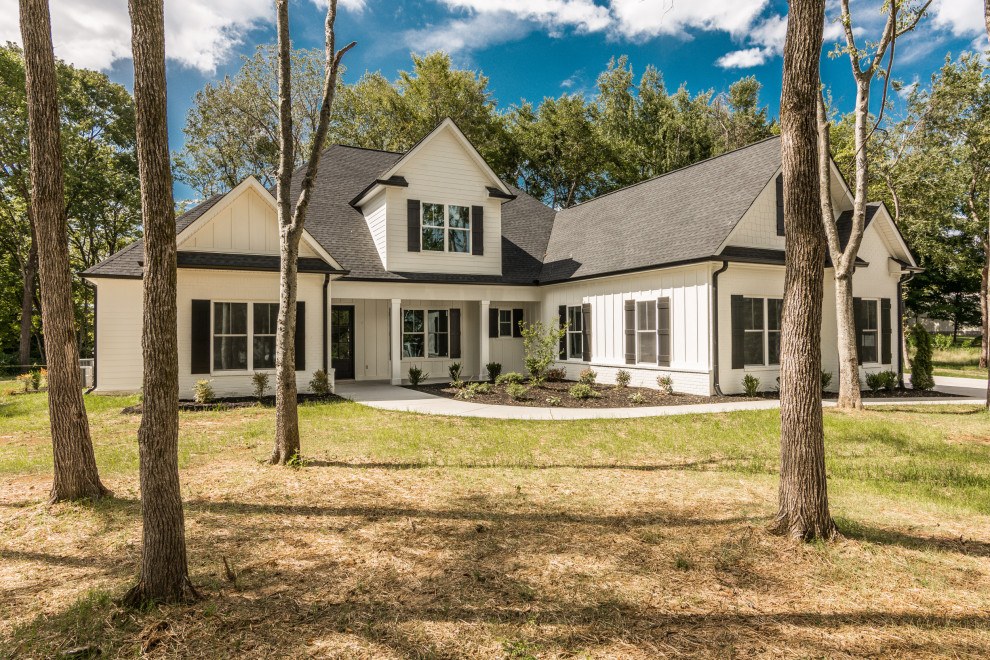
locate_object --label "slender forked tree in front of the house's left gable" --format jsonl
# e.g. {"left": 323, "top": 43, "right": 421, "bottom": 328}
{"left": 270, "top": 0, "right": 357, "bottom": 465}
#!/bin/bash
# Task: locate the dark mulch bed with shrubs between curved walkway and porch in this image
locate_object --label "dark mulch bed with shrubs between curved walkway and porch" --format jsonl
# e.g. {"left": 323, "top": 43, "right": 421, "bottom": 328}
{"left": 406, "top": 381, "right": 758, "bottom": 408}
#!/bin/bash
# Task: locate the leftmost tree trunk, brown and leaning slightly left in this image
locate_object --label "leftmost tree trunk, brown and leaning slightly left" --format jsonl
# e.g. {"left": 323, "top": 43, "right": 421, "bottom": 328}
{"left": 20, "top": 0, "right": 110, "bottom": 502}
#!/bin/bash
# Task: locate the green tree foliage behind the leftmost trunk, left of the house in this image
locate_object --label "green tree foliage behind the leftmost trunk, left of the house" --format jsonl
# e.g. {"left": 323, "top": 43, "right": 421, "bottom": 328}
{"left": 0, "top": 43, "right": 141, "bottom": 358}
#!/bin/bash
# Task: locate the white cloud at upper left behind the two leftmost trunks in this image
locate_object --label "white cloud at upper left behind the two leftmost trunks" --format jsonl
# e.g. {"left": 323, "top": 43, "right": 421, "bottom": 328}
{"left": 0, "top": 0, "right": 365, "bottom": 74}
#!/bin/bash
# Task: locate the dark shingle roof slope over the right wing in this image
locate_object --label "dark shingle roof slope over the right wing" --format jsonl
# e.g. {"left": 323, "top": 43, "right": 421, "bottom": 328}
{"left": 540, "top": 137, "right": 781, "bottom": 282}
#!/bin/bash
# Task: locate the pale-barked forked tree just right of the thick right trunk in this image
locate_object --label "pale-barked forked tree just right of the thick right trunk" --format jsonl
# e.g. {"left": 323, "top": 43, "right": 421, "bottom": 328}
{"left": 817, "top": 0, "right": 932, "bottom": 409}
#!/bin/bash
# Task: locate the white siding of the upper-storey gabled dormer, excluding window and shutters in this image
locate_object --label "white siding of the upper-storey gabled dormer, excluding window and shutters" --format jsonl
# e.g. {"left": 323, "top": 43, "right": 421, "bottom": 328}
{"left": 376, "top": 129, "right": 502, "bottom": 275}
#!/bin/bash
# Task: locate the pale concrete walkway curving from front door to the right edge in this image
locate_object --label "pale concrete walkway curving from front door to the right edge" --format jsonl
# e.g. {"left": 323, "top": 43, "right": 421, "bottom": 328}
{"left": 336, "top": 376, "right": 986, "bottom": 420}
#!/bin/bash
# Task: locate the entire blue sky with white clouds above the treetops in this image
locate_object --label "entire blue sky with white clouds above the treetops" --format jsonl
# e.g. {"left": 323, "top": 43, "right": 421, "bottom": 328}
{"left": 0, "top": 0, "right": 987, "bottom": 199}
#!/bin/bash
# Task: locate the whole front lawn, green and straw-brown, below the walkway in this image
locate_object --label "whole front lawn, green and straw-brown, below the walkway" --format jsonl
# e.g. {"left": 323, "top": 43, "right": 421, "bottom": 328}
{"left": 0, "top": 395, "right": 990, "bottom": 659}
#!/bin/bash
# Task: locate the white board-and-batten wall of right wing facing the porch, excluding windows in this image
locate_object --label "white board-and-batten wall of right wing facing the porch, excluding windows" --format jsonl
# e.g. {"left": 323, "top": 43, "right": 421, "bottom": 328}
{"left": 542, "top": 263, "right": 711, "bottom": 395}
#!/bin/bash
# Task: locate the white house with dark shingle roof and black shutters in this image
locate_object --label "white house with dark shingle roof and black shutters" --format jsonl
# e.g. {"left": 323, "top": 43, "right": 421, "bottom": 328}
{"left": 83, "top": 119, "right": 916, "bottom": 397}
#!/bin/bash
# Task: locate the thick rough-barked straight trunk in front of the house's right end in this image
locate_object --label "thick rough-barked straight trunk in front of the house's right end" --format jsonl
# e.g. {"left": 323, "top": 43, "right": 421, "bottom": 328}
{"left": 770, "top": 0, "right": 837, "bottom": 539}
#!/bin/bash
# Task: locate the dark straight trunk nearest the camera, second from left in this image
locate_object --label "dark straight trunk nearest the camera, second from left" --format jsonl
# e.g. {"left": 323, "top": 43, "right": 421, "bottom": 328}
{"left": 124, "top": 0, "right": 197, "bottom": 606}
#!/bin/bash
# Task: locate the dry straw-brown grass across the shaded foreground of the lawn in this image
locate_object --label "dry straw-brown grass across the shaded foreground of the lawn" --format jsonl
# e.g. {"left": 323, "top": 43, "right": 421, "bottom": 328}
{"left": 0, "top": 452, "right": 990, "bottom": 659}
